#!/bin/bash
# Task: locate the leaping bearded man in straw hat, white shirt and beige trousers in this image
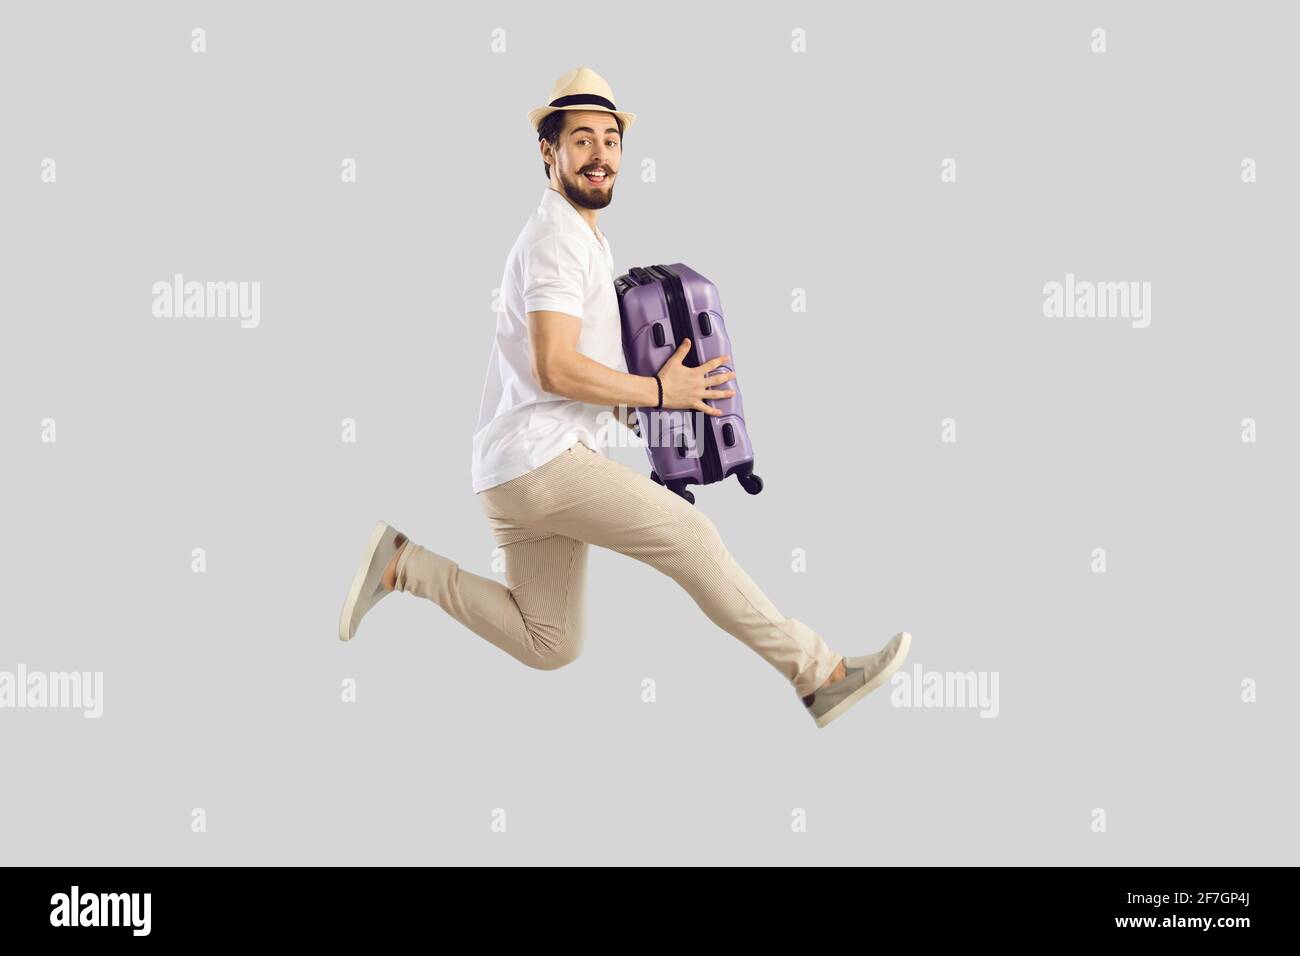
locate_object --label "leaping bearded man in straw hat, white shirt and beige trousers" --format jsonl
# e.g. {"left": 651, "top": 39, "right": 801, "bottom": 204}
{"left": 339, "top": 66, "right": 911, "bottom": 727}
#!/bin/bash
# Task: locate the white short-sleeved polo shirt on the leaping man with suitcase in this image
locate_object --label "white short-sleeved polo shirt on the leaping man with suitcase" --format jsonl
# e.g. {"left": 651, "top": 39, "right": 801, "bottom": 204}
{"left": 472, "top": 186, "right": 628, "bottom": 493}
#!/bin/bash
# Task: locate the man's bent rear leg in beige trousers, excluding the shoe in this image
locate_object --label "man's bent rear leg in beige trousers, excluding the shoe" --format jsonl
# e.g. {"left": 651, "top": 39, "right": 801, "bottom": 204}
{"left": 395, "top": 509, "right": 588, "bottom": 670}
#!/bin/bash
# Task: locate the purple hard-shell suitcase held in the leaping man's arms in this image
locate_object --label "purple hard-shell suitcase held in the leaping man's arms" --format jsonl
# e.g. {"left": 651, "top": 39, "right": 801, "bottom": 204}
{"left": 614, "top": 263, "right": 763, "bottom": 503}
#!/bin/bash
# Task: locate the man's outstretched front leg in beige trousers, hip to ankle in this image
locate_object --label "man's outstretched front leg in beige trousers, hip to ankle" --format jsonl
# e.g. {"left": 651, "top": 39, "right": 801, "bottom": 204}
{"left": 520, "top": 444, "right": 844, "bottom": 697}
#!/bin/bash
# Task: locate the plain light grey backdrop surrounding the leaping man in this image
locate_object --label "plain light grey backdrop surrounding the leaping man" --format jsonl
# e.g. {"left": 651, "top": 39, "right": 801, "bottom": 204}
{"left": 0, "top": 3, "right": 1300, "bottom": 865}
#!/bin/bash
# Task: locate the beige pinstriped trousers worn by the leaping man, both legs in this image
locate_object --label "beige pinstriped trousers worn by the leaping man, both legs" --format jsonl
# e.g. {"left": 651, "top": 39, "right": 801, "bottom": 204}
{"left": 397, "top": 441, "right": 840, "bottom": 697}
